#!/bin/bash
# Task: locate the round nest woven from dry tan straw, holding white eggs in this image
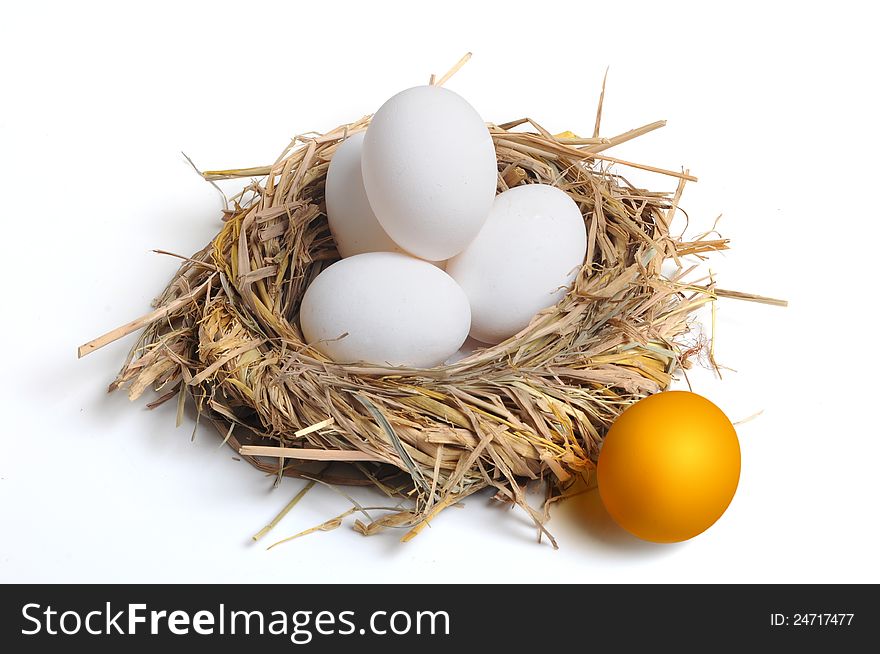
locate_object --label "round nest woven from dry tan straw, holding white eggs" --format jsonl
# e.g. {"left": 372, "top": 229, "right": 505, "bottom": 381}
{"left": 80, "top": 57, "right": 775, "bottom": 545}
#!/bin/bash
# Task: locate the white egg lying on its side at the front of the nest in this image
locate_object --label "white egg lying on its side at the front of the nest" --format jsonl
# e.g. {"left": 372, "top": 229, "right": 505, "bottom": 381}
{"left": 299, "top": 252, "right": 471, "bottom": 368}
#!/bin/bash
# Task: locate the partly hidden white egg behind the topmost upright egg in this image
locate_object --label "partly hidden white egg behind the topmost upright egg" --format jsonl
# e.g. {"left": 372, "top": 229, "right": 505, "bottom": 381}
{"left": 324, "top": 132, "right": 402, "bottom": 257}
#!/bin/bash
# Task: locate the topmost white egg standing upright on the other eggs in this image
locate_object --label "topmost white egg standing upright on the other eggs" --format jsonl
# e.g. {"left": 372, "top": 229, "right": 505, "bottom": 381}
{"left": 362, "top": 86, "right": 498, "bottom": 261}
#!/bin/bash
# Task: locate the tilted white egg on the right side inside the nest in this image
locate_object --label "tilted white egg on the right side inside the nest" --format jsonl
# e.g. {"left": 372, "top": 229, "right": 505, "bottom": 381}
{"left": 446, "top": 184, "right": 587, "bottom": 343}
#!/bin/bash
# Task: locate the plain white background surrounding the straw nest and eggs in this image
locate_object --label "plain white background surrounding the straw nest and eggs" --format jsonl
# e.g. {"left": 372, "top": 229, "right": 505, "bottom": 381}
{"left": 0, "top": 0, "right": 880, "bottom": 582}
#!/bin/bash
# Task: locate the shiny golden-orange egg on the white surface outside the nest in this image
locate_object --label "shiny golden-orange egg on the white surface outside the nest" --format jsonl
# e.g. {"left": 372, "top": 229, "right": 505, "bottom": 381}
{"left": 597, "top": 391, "right": 740, "bottom": 543}
